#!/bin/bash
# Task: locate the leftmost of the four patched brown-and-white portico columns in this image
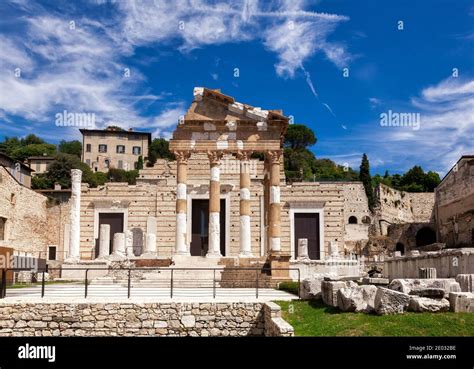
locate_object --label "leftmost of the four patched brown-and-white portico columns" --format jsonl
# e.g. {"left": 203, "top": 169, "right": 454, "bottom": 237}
{"left": 174, "top": 151, "right": 191, "bottom": 255}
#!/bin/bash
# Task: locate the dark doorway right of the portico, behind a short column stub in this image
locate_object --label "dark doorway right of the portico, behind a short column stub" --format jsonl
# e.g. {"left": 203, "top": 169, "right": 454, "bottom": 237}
{"left": 294, "top": 213, "right": 320, "bottom": 260}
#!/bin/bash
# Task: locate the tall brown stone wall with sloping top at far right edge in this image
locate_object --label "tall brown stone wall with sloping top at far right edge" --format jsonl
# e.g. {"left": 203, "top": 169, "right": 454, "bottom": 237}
{"left": 436, "top": 158, "right": 474, "bottom": 247}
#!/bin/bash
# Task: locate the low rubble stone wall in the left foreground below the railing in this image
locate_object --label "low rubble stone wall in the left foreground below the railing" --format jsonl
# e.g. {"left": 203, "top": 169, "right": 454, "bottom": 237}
{"left": 0, "top": 301, "right": 293, "bottom": 337}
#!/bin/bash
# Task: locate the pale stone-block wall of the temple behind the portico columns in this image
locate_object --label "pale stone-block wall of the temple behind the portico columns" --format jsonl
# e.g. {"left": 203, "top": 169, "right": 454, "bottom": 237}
{"left": 81, "top": 153, "right": 369, "bottom": 257}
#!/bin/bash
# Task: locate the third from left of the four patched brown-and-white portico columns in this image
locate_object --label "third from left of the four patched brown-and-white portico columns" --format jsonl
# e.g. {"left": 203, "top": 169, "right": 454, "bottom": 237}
{"left": 237, "top": 151, "right": 252, "bottom": 257}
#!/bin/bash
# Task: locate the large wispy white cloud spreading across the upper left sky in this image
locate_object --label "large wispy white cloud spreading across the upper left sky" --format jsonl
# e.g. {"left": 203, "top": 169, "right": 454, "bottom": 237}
{"left": 0, "top": 0, "right": 348, "bottom": 135}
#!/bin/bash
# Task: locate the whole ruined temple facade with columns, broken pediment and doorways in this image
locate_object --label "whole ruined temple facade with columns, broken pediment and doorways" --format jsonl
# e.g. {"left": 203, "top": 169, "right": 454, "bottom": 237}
{"left": 64, "top": 88, "right": 370, "bottom": 260}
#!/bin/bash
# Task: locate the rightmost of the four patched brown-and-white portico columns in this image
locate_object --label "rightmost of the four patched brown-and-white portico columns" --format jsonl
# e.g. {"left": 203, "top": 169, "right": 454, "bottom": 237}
{"left": 267, "top": 151, "right": 281, "bottom": 253}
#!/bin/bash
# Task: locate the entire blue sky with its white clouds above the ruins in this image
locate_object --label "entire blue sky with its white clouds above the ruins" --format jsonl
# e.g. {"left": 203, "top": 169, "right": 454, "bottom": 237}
{"left": 0, "top": 0, "right": 474, "bottom": 174}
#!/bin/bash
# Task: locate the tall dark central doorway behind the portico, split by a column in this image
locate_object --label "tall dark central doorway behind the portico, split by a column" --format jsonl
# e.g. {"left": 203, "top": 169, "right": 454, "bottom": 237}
{"left": 190, "top": 199, "right": 226, "bottom": 256}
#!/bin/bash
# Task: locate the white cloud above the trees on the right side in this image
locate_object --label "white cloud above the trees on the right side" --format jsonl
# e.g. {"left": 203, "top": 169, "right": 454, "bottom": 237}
{"left": 326, "top": 78, "right": 474, "bottom": 173}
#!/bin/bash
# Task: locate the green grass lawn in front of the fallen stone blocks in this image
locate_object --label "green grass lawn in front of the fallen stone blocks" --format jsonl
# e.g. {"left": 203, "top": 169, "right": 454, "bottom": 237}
{"left": 277, "top": 301, "right": 474, "bottom": 336}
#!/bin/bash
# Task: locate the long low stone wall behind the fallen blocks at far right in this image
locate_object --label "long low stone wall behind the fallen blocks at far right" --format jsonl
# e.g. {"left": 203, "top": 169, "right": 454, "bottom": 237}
{"left": 383, "top": 248, "right": 474, "bottom": 279}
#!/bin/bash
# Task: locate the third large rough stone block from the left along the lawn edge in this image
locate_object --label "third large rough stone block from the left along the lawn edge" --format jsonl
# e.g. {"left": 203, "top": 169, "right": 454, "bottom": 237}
{"left": 337, "top": 285, "right": 377, "bottom": 312}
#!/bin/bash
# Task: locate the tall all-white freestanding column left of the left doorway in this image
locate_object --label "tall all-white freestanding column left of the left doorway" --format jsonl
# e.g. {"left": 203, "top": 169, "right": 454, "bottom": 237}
{"left": 66, "top": 169, "right": 82, "bottom": 262}
